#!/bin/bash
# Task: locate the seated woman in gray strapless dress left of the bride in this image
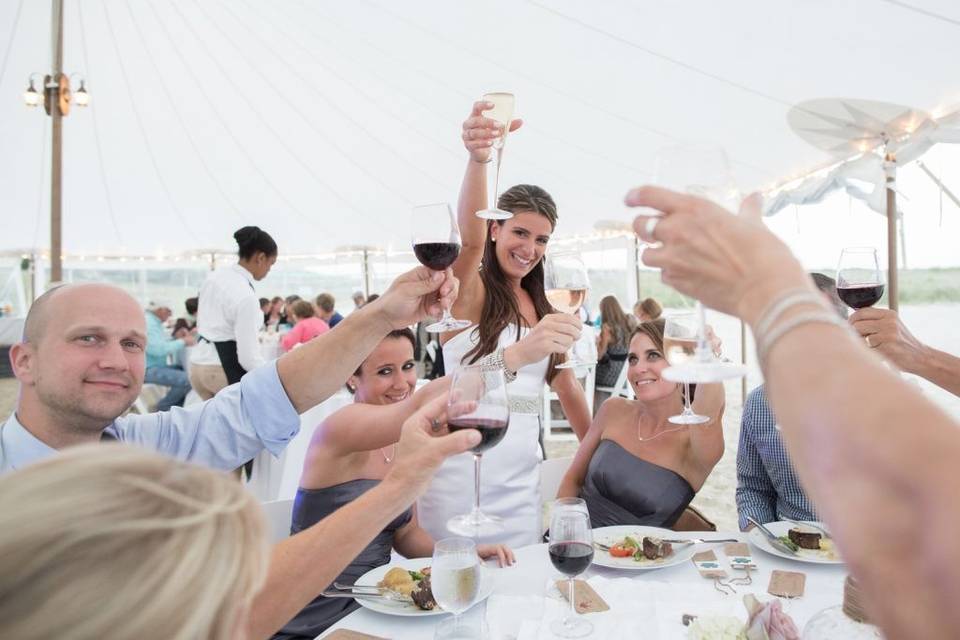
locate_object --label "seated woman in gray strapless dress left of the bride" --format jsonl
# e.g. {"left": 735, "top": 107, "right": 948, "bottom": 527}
{"left": 273, "top": 329, "right": 513, "bottom": 640}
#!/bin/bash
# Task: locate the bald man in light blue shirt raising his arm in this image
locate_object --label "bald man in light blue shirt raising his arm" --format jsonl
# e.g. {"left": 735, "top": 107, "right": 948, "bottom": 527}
{"left": 0, "top": 268, "right": 457, "bottom": 473}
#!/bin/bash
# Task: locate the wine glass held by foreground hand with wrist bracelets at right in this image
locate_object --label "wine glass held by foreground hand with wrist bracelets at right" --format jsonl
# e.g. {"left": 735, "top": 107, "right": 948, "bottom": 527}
{"left": 656, "top": 145, "right": 747, "bottom": 383}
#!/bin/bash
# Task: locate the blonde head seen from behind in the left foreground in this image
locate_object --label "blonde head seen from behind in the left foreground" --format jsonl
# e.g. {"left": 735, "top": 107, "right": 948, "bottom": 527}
{"left": 0, "top": 444, "right": 268, "bottom": 640}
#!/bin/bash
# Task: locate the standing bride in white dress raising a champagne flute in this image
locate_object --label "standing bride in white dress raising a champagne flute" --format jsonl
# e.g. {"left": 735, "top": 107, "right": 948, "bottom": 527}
{"left": 417, "top": 102, "right": 590, "bottom": 547}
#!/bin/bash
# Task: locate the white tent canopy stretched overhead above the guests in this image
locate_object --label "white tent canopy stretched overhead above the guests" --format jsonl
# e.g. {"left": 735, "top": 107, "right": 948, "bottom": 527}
{"left": 0, "top": 0, "right": 960, "bottom": 255}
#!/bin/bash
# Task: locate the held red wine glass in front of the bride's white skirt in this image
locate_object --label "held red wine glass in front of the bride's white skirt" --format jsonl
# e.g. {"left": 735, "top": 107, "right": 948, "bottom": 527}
{"left": 447, "top": 365, "right": 510, "bottom": 537}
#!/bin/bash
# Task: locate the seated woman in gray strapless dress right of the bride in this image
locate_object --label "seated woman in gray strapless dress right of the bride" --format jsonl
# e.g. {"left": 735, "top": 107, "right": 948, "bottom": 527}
{"left": 558, "top": 319, "right": 724, "bottom": 527}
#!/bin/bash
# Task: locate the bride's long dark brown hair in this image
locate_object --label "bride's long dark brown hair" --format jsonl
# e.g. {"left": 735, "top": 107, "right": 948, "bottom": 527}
{"left": 463, "top": 184, "right": 563, "bottom": 382}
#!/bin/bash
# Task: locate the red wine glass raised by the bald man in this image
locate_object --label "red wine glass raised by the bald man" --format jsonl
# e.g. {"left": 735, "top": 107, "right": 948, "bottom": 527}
{"left": 410, "top": 202, "right": 470, "bottom": 333}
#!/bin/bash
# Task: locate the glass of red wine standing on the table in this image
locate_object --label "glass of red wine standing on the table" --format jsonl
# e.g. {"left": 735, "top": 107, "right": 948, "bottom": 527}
{"left": 548, "top": 501, "right": 593, "bottom": 638}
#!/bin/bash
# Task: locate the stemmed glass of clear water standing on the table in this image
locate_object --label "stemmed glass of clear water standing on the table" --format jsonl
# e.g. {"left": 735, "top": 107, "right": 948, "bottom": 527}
{"left": 430, "top": 538, "right": 481, "bottom": 640}
